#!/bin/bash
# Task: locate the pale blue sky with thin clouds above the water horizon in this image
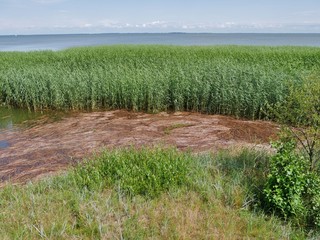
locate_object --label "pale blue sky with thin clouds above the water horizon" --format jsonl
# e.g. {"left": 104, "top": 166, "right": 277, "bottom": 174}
{"left": 0, "top": 0, "right": 320, "bottom": 35}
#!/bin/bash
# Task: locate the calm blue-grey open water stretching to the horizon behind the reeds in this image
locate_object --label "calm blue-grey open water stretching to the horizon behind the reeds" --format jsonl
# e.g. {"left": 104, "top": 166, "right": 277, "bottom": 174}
{"left": 0, "top": 33, "right": 320, "bottom": 51}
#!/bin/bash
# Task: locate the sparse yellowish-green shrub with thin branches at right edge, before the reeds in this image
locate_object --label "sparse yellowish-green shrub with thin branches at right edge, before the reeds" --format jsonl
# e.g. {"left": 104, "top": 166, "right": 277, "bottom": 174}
{"left": 272, "top": 73, "right": 320, "bottom": 171}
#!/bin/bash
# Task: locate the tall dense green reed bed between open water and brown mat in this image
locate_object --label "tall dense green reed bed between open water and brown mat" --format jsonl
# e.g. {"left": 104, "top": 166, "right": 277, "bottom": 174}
{"left": 0, "top": 46, "right": 320, "bottom": 119}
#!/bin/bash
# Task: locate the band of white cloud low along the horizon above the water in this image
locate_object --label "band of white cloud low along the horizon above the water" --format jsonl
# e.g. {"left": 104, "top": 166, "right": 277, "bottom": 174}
{"left": 0, "top": 18, "right": 320, "bottom": 34}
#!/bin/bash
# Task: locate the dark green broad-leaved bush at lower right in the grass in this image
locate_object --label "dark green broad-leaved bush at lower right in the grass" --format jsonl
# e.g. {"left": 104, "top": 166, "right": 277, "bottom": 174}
{"left": 264, "top": 140, "right": 320, "bottom": 228}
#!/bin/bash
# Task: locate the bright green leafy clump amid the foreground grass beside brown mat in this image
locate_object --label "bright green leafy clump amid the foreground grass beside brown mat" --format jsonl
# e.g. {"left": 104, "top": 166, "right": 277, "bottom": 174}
{"left": 74, "top": 148, "right": 191, "bottom": 198}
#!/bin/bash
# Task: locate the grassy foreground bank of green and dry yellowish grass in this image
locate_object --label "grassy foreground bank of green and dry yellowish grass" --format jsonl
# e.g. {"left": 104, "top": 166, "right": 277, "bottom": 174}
{"left": 0, "top": 148, "right": 305, "bottom": 239}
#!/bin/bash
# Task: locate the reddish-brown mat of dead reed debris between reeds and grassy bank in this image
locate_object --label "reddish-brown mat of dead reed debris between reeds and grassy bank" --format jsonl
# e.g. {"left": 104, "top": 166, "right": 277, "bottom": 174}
{"left": 0, "top": 110, "right": 278, "bottom": 185}
